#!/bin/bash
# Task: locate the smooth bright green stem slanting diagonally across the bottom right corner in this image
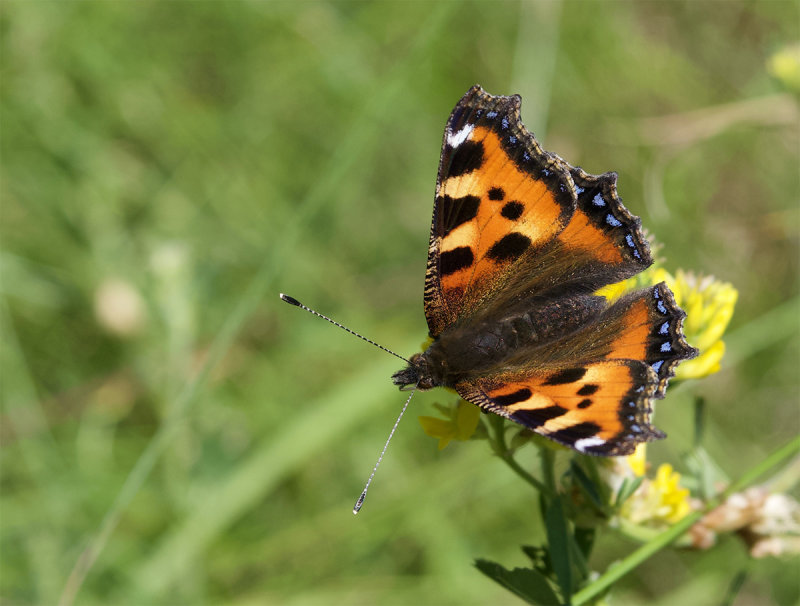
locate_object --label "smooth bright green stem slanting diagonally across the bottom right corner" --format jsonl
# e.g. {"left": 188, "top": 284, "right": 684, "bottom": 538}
{"left": 571, "top": 436, "right": 800, "bottom": 606}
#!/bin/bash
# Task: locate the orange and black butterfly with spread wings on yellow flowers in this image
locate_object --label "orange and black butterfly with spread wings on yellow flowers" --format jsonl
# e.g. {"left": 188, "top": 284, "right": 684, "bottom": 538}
{"left": 392, "top": 86, "right": 697, "bottom": 456}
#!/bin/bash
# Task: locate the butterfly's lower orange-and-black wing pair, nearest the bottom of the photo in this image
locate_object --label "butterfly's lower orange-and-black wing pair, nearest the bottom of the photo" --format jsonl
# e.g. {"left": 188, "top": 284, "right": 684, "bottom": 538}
{"left": 456, "top": 283, "right": 697, "bottom": 455}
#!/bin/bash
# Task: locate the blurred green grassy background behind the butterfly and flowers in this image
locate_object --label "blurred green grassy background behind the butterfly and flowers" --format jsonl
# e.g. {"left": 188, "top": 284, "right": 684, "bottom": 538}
{"left": 0, "top": 0, "right": 800, "bottom": 605}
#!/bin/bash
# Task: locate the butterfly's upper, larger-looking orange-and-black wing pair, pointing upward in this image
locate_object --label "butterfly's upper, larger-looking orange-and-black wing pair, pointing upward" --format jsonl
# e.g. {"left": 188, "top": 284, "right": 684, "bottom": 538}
{"left": 425, "top": 86, "right": 651, "bottom": 336}
